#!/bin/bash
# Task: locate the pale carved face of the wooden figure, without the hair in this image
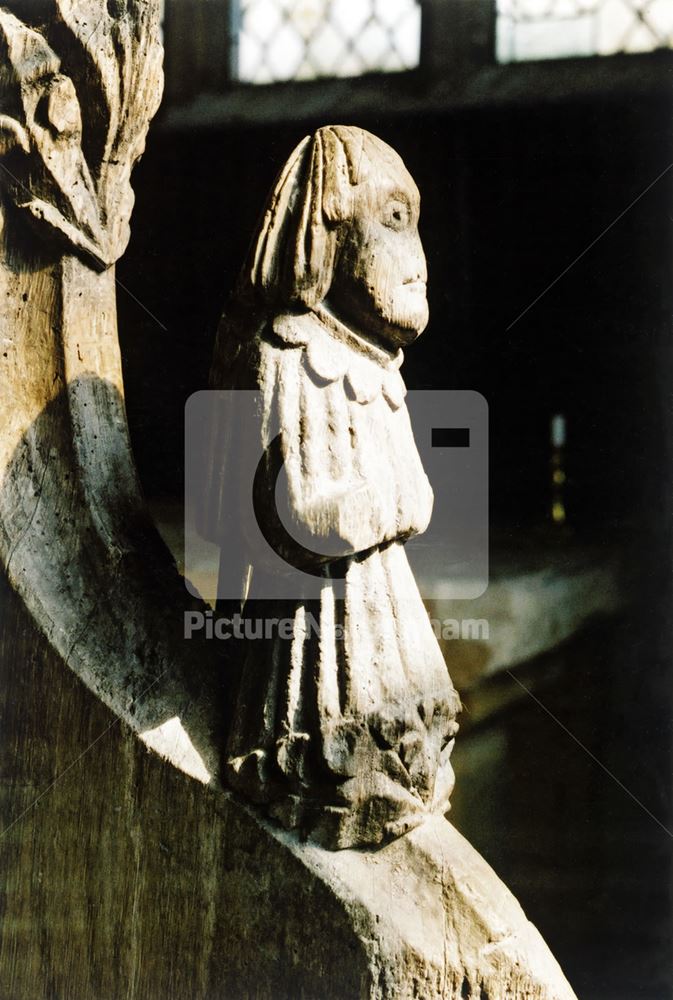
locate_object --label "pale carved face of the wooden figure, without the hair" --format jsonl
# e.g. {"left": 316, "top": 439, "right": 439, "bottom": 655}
{"left": 328, "top": 147, "right": 428, "bottom": 348}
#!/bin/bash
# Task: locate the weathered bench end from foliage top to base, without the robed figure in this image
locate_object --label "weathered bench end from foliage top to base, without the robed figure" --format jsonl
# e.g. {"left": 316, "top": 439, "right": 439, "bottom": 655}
{"left": 0, "top": 0, "right": 572, "bottom": 1000}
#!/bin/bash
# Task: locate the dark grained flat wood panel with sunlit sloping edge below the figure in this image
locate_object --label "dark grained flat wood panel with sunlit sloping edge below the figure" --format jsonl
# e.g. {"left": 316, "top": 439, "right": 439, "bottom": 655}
{"left": 0, "top": 572, "right": 573, "bottom": 1000}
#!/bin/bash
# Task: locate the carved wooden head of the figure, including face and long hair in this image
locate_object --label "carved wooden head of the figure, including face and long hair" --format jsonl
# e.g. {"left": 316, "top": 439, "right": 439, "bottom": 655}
{"left": 245, "top": 125, "right": 428, "bottom": 347}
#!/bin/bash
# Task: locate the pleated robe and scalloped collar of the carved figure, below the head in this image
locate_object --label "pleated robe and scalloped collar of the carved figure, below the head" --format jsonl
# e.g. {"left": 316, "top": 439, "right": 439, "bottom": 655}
{"left": 213, "top": 307, "right": 459, "bottom": 847}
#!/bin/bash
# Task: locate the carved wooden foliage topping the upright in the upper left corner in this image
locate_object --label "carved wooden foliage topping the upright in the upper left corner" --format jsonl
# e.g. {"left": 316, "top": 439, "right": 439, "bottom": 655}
{"left": 0, "top": 0, "right": 162, "bottom": 270}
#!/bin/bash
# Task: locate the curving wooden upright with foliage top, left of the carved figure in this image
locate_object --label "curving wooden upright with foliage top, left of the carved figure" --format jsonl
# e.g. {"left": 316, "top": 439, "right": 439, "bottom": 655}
{"left": 0, "top": 0, "right": 222, "bottom": 780}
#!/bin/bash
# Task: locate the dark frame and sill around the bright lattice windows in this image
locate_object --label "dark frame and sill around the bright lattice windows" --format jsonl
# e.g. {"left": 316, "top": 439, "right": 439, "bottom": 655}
{"left": 158, "top": 0, "right": 673, "bottom": 129}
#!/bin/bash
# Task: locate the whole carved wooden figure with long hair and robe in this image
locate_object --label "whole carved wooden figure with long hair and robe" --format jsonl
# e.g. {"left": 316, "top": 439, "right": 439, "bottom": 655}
{"left": 209, "top": 126, "right": 459, "bottom": 848}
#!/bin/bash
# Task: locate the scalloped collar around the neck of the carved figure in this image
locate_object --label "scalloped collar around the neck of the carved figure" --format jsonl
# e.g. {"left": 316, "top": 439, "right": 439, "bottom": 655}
{"left": 273, "top": 306, "right": 407, "bottom": 410}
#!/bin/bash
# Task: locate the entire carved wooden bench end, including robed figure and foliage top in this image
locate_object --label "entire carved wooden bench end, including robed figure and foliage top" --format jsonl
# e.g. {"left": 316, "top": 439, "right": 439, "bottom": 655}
{"left": 0, "top": 0, "right": 574, "bottom": 984}
